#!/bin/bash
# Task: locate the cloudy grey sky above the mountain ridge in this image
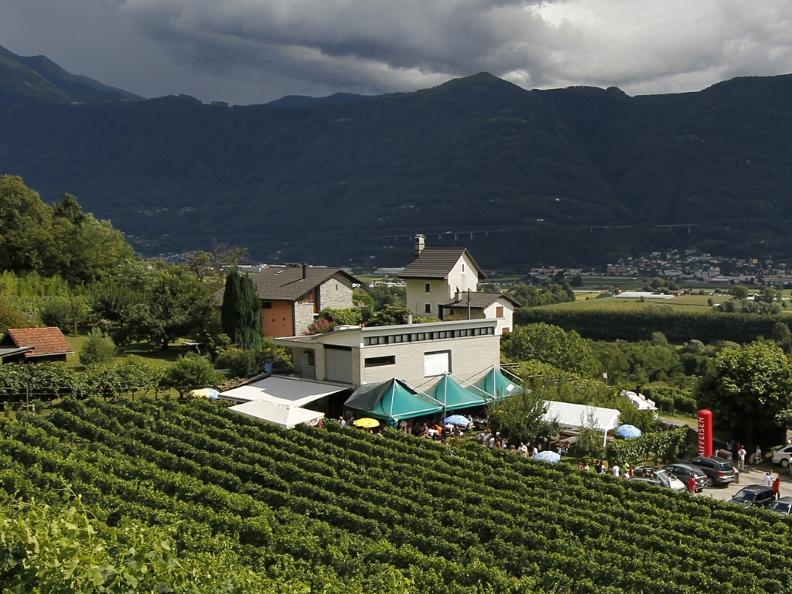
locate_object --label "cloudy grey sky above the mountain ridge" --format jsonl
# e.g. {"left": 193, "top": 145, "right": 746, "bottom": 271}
{"left": 0, "top": 0, "right": 792, "bottom": 104}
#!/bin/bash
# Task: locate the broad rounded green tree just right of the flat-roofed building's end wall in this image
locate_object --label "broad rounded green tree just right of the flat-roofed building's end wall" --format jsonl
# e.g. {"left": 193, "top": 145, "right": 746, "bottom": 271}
{"left": 502, "top": 323, "right": 598, "bottom": 376}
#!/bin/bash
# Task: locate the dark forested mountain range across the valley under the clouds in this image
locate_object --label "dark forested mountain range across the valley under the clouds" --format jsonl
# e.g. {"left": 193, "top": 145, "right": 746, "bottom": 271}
{"left": 0, "top": 48, "right": 792, "bottom": 268}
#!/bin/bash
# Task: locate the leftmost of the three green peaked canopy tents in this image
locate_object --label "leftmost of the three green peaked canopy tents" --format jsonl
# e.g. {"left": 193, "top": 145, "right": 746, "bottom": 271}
{"left": 344, "top": 378, "right": 443, "bottom": 424}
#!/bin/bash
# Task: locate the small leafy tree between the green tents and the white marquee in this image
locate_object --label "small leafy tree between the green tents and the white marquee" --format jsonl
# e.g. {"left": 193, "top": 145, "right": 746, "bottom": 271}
{"left": 489, "top": 390, "right": 558, "bottom": 443}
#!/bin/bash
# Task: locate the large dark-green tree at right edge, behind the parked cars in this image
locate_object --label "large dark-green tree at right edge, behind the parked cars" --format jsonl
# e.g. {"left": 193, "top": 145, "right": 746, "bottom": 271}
{"left": 698, "top": 341, "right": 792, "bottom": 444}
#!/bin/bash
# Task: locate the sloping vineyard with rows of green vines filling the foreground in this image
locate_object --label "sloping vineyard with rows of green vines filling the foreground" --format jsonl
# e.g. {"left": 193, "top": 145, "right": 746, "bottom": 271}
{"left": 0, "top": 399, "right": 792, "bottom": 594}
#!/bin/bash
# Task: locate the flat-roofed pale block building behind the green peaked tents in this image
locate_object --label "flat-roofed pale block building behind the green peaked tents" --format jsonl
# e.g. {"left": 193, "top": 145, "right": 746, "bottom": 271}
{"left": 275, "top": 319, "right": 500, "bottom": 390}
